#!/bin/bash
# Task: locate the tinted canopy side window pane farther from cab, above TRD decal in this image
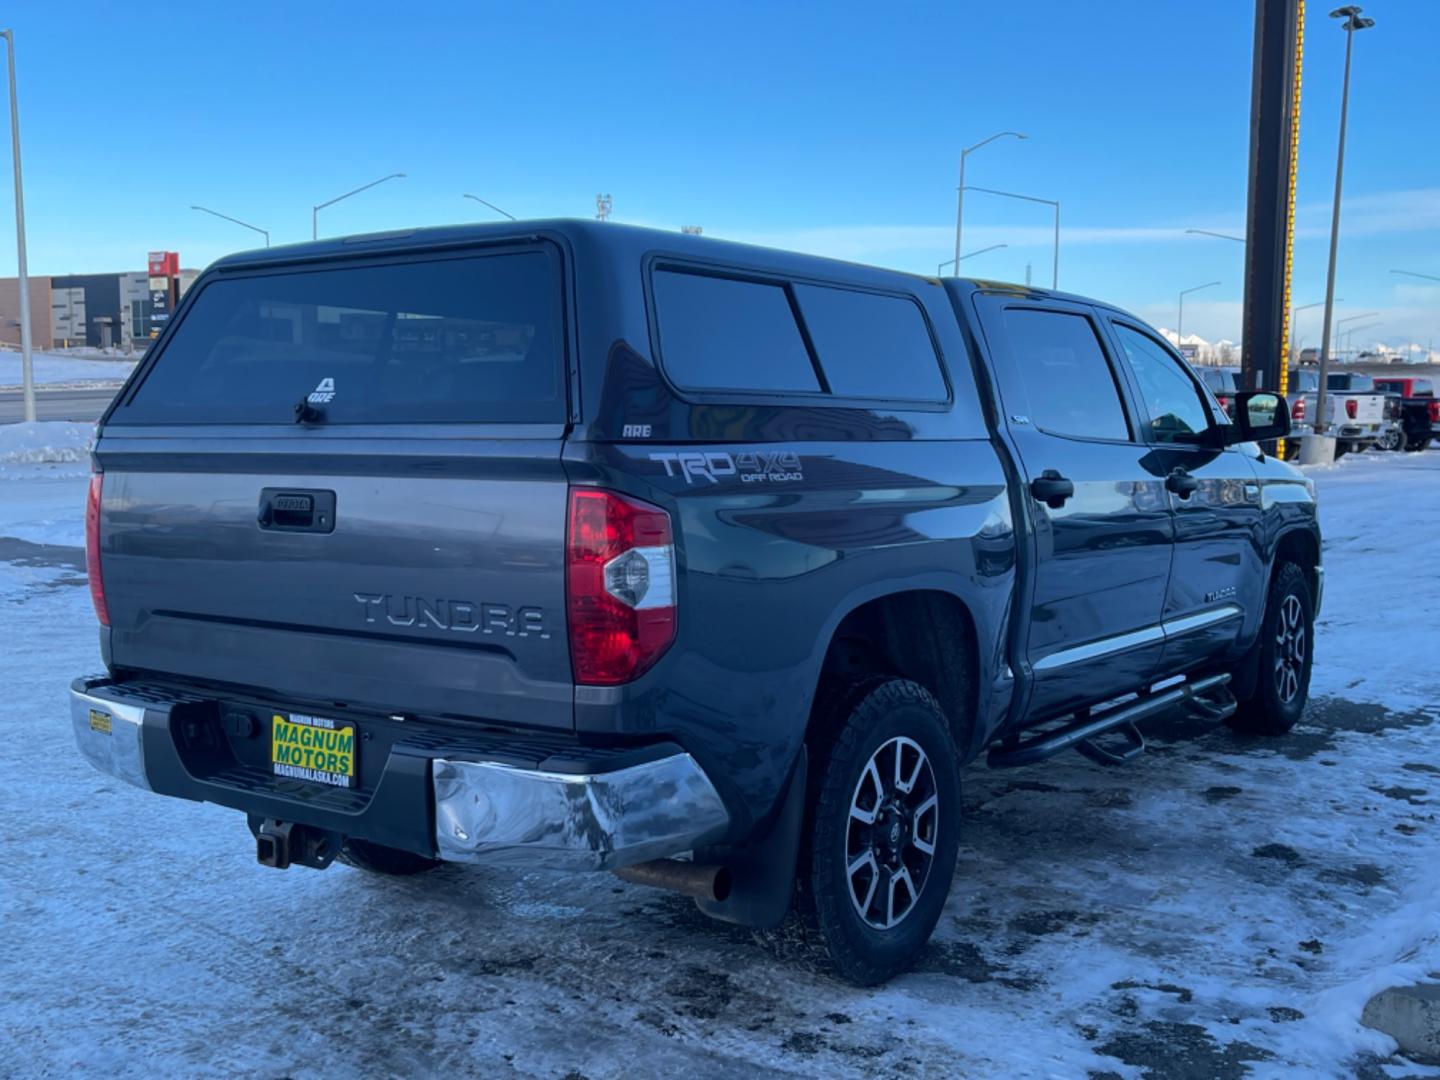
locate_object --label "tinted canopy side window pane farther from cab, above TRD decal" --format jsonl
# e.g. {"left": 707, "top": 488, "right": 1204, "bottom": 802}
{"left": 654, "top": 269, "right": 821, "bottom": 393}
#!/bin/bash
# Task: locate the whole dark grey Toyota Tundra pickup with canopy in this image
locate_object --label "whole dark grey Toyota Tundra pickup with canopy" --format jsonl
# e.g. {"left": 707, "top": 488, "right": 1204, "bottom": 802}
{"left": 71, "top": 222, "right": 1323, "bottom": 984}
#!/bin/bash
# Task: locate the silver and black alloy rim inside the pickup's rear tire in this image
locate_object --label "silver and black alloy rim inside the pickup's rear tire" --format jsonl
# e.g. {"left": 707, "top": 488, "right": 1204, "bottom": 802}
{"left": 845, "top": 736, "right": 940, "bottom": 930}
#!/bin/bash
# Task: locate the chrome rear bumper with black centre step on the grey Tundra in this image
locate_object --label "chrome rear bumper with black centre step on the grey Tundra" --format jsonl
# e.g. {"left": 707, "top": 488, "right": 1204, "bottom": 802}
{"left": 71, "top": 678, "right": 730, "bottom": 870}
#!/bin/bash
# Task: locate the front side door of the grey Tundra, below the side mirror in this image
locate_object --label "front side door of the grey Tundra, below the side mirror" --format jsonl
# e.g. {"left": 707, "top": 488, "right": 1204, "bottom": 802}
{"left": 1107, "top": 318, "right": 1266, "bottom": 675}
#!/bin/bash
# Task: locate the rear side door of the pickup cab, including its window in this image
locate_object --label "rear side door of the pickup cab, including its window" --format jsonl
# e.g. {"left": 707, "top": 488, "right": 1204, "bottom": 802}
{"left": 975, "top": 294, "right": 1174, "bottom": 716}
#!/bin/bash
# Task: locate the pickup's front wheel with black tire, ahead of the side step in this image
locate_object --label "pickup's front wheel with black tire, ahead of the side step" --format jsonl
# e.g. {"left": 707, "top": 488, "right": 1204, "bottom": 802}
{"left": 1230, "top": 563, "right": 1315, "bottom": 734}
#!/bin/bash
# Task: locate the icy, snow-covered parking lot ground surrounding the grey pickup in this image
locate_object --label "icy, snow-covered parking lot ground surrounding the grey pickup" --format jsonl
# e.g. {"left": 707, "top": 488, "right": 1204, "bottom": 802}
{"left": 0, "top": 431, "right": 1440, "bottom": 1079}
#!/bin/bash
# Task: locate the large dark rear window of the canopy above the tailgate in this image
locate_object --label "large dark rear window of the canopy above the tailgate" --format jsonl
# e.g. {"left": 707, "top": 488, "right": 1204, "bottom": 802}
{"left": 111, "top": 251, "right": 567, "bottom": 423}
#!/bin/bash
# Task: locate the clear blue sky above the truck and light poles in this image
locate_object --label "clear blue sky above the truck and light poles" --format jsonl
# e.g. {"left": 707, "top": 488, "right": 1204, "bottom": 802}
{"left": 0, "top": 0, "right": 1440, "bottom": 351}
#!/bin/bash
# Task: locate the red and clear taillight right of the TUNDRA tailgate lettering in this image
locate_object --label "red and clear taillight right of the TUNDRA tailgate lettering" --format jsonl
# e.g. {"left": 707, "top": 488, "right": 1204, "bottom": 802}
{"left": 566, "top": 488, "right": 675, "bottom": 687}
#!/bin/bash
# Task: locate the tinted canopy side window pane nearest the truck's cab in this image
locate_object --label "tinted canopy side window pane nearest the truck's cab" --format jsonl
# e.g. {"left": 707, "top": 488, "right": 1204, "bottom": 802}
{"left": 793, "top": 285, "right": 948, "bottom": 402}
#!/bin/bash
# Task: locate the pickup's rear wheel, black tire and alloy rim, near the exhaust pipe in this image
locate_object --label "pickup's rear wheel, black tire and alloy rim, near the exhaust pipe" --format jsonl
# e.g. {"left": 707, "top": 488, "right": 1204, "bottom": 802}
{"left": 795, "top": 678, "right": 960, "bottom": 986}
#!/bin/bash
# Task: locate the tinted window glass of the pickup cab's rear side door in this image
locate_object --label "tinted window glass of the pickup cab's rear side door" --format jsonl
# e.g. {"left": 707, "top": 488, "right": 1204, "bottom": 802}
{"left": 1005, "top": 308, "right": 1130, "bottom": 439}
